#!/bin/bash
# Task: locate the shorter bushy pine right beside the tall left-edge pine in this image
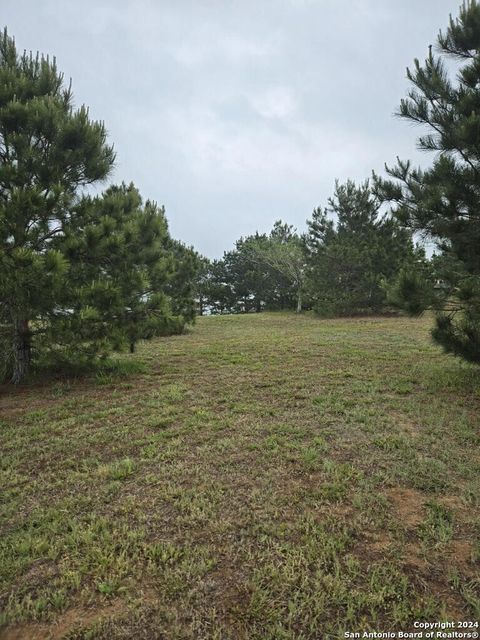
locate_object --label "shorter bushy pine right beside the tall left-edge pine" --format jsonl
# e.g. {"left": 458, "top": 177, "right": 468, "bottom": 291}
{"left": 54, "top": 184, "right": 191, "bottom": 357}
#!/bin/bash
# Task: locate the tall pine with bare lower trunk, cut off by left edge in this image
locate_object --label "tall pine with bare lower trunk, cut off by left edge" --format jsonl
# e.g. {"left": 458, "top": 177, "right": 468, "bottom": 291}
{"left": 0, "top": 30, "right": 114, "bottom": 382}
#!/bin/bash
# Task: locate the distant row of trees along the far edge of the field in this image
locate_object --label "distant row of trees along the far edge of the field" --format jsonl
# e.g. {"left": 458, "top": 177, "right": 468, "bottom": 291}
{"left": 198, "top": 180, "right": 425, "bottom": 316}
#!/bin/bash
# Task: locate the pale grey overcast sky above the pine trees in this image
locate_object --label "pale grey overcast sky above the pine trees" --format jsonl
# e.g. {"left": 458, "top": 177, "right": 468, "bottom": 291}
{"left": 0, "top": 0, "right": 460, "bottom": 258}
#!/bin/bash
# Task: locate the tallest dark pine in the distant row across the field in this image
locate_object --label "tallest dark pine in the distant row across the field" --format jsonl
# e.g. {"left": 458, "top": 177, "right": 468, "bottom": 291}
{"left": 306, "top": 180, "right": 415, "bottom": 315}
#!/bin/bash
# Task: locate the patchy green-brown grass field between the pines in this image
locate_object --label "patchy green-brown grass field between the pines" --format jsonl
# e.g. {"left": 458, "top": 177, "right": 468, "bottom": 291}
{"left": 0, "top": 314, "right": 480, "bottom": 640}
